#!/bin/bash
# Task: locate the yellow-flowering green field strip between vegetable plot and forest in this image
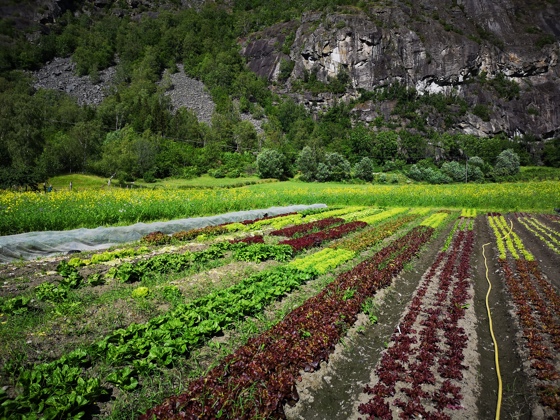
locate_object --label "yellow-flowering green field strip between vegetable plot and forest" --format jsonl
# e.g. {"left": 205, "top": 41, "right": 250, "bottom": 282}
{"left": 0, "top": 177, "right": 560, "bottom": 235}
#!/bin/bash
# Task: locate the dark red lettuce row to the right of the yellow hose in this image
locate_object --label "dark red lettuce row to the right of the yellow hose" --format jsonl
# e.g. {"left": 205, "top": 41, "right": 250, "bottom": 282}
{"left": 500, "top": 260, "right": 560, "bottom": 417}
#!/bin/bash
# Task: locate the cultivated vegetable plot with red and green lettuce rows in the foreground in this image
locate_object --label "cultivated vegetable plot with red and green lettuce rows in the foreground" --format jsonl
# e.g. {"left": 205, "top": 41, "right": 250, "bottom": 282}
{"left": 0, "top": 205, "right": 560, "bottom": 419}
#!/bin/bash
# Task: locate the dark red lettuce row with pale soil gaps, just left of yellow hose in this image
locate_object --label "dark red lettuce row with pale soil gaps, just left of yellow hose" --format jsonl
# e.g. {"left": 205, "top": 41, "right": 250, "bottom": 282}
{"left": 359, "top": 225, "right": 474, "bottom": 419}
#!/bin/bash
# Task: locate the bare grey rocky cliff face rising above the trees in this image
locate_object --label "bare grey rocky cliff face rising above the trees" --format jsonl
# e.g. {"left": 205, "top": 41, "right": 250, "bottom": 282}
{"left": 242, "top": 0, "right": 560, "bottom": 138}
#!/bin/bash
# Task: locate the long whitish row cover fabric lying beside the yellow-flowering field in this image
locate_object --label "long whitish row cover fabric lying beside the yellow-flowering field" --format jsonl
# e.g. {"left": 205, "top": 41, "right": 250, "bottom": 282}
{"left": 0, "top": 204, "right": 327, "bottom": 263}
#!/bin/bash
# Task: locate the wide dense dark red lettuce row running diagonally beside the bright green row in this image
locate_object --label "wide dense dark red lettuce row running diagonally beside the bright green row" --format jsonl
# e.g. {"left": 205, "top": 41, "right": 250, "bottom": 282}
{"left": 141, "top": 227, "right": 433, "bottom": 419}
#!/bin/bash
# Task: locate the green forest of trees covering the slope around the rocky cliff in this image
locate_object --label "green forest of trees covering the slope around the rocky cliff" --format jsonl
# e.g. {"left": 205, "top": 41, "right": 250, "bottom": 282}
{"left": 0, "top": 0, "right": 560, "bottom": 188}
